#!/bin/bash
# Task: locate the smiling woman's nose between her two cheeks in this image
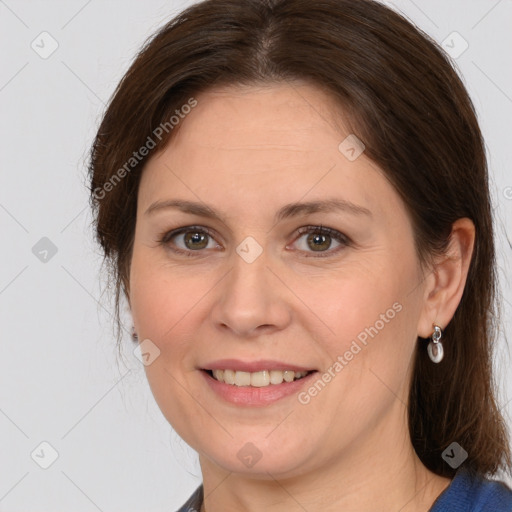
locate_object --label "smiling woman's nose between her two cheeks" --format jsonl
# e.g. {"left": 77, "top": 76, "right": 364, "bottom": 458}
{"left": 211, "top": 246, "right": 292, "bottom": 338}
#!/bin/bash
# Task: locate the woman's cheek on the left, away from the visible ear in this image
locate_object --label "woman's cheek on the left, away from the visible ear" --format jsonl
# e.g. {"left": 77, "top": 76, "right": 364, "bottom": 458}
{"left": 131, "top": 254, "right": 206, "bottom": 441}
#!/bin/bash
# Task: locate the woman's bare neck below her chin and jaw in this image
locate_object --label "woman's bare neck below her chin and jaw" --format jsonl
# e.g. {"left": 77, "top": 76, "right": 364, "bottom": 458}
{"left": 200, "top": 410, "right": 450, "bottom": 512}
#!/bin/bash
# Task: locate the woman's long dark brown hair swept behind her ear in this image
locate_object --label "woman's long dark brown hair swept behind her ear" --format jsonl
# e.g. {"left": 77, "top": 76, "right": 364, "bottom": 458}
{"left": 89, "top": 0, "right": 512, "bottom": 476}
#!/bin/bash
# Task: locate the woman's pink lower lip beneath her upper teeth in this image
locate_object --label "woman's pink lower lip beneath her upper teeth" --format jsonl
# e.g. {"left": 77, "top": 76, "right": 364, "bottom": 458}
{"left": 201, "top": 370, "right": 317, "bottom": 406}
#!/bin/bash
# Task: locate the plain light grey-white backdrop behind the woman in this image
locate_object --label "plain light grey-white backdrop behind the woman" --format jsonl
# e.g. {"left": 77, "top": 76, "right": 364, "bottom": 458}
{"left": 0, "top": 0, "right": 512, "bottom": 512}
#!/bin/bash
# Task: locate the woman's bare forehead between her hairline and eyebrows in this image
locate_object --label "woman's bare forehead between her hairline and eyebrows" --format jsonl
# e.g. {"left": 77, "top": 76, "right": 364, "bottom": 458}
{"left": 140, "top": 84, "right": 396, "bottom": 226}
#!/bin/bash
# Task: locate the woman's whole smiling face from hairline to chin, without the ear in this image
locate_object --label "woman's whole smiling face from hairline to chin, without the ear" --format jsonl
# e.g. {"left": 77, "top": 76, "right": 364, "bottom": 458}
{"left": 130, "top": 83, "right": 424, "bottom": 478}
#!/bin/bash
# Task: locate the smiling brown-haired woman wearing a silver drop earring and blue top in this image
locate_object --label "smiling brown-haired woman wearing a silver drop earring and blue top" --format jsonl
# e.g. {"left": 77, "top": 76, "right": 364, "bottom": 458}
{"left": 90, "top": 0, "right": 512, "bottom": 512}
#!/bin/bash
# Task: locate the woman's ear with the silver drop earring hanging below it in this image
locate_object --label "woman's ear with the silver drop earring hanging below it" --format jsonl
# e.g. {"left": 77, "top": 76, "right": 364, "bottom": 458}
{"left": 418, "top": 218, "right": 475, "bottom": 338}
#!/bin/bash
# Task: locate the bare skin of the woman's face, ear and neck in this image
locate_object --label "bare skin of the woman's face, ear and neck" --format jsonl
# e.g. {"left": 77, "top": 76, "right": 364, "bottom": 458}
{"left": 129, "top": 82, "right": 474, "bottom": 512}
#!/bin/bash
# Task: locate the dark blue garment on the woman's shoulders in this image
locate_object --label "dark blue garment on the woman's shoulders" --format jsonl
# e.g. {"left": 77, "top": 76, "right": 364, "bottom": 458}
{"left": 177, "top": 466, "right": 512, "bottom": 512}
